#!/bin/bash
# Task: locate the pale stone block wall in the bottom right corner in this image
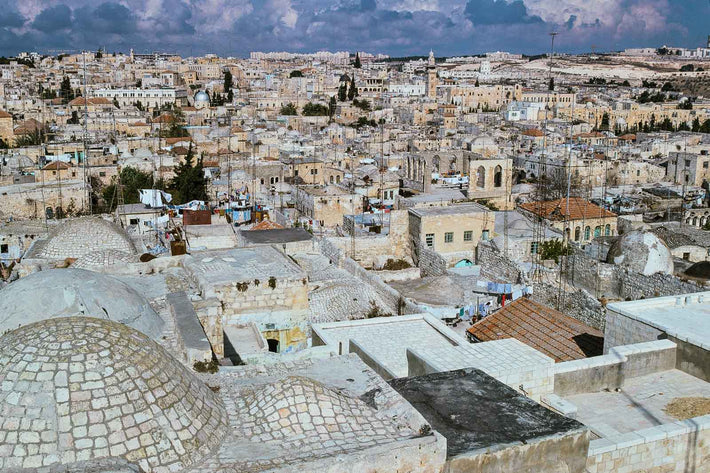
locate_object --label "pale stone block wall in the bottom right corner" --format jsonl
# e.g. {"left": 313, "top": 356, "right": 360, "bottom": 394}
{"left": 587, "top": 415, "right": 710, "bottom": 473}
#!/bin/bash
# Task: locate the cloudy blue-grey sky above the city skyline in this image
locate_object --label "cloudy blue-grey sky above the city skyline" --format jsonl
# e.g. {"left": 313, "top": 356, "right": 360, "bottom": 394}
{"left": 0, "top": 0, "right": 710, "bottom": 56}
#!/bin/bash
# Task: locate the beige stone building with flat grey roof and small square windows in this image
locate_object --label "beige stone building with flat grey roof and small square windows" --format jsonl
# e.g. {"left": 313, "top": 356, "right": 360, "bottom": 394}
{"left": 409, "top": 203, "right": 495, "bottom": 263}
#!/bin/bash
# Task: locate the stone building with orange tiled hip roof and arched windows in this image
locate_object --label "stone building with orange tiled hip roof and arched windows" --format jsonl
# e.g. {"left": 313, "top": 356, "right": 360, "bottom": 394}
{"left": 519, "top": 197, "right": 618, "bottom": 243}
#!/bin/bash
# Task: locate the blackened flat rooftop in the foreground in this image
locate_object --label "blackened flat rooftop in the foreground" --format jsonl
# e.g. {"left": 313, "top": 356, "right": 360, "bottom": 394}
{"left": 389, "top": 368, "right": 586, "bottom": 458}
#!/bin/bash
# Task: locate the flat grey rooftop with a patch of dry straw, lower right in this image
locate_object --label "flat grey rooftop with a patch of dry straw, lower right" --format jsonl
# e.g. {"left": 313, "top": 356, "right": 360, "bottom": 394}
{"left": 565, "top": 370, "right": 710, "bottom": 437}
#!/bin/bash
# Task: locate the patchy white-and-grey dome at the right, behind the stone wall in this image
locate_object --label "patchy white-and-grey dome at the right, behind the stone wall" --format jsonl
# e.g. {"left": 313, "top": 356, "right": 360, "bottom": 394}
{"left": 606, "top": 230, "right": 673, "bottom": 276}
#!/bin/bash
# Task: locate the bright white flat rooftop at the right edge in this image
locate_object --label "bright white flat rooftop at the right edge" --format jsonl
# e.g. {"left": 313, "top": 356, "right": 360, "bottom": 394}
{"left": 607, "top": 291, "right": 710, "bottom": 350}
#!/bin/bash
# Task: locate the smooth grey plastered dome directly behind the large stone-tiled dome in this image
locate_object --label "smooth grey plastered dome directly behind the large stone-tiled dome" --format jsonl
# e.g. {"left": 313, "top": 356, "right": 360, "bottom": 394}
{"left": 0, "top": 269, "right": 164, "bottom": 339}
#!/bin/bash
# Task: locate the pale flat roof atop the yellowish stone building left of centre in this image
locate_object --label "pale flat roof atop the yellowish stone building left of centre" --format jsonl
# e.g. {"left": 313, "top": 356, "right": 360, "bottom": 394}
{"left": 184, "top": 246, "right": 306, "bottom": 286}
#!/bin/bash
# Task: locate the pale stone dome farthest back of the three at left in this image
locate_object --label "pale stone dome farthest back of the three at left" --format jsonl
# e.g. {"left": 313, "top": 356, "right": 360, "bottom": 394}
{"left": 32, "top": 217, "right": 136, "bottom": 259}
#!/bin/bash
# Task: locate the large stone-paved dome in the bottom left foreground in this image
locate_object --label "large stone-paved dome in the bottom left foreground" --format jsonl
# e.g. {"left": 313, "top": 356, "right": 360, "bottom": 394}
{"left": 0, "top": 317, "right": 228, "bottom": 473}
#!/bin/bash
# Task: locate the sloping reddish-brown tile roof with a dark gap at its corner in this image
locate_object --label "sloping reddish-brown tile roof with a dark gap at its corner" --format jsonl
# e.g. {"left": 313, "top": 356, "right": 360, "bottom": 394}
{"left": 468, "top": 298, "right": 604, "bottom": 362}
